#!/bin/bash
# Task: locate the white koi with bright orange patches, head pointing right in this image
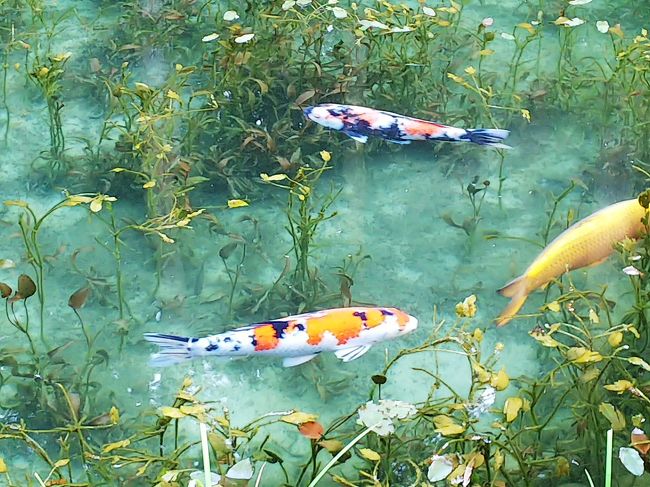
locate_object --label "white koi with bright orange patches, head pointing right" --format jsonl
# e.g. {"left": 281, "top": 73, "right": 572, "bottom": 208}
{"left": 144, "top": 307, "right": 418, "bottom": 367}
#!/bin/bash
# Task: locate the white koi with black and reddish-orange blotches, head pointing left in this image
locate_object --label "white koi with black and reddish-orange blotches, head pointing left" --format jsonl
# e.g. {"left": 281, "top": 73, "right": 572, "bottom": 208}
{"left": 303, "top": 103, "right": 511, "bottom": 149}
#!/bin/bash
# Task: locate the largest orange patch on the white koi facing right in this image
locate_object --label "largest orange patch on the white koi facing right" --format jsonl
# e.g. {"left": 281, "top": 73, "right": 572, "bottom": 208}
{"left": 306, "top": 308, "right": 384, "bottom": 345}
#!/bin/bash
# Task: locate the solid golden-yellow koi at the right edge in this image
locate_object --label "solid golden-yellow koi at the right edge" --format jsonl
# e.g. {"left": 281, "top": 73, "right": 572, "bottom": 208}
{"left": 496, "top": 198, "right": 646, "bottom": 326}
